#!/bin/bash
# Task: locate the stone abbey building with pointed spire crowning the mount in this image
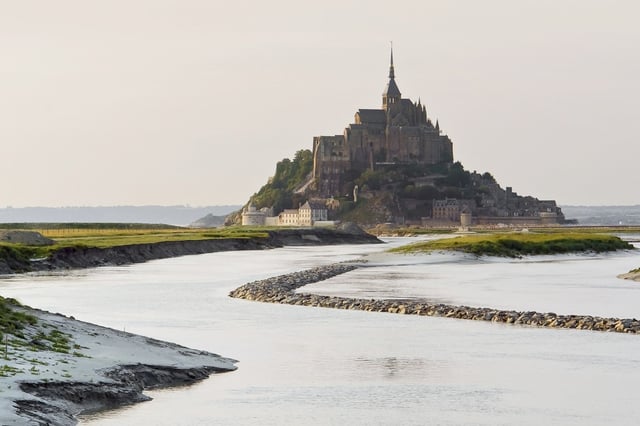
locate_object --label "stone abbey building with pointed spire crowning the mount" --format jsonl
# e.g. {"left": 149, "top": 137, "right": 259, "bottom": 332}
{"left": 313, "top": 50, "right": 453, "bottom": 197}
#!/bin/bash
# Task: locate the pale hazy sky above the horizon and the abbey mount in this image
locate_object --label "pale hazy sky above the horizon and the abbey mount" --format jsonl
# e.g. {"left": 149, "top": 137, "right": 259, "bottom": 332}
{"left": 0, "top": 0, "right": 640, "bottom": 207}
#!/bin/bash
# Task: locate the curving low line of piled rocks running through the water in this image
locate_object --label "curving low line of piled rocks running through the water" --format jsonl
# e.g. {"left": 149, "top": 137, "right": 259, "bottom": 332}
{"left": 229, "top": 263, "right": 640, "bottom": 334}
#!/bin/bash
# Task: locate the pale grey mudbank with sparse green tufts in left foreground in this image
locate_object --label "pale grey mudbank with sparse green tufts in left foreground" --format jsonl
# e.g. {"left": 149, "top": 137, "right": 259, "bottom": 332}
{"left": 0, "top": 307, "right": 237, "bottom": 426}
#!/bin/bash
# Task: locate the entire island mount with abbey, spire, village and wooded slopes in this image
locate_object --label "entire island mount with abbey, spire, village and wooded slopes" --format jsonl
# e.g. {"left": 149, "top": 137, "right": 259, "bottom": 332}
{"left": 235, "top": 51, "right": 566, "bottom": 227}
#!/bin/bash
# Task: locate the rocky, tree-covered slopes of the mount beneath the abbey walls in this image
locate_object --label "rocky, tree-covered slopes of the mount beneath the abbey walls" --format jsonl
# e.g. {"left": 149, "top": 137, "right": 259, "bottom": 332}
{"left": 231, "top": 150, "right": 564, "bottom": 225}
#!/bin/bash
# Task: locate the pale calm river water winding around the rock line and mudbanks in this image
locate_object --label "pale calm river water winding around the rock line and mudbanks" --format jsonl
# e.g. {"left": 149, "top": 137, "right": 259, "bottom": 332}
{"left": 0, "top": 239, "right": 640, "bottom": 426}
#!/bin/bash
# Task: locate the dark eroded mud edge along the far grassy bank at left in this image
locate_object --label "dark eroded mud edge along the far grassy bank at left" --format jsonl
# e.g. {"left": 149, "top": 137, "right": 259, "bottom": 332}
{"left": 0, "top": 227, "right": 382, "bottom": 275}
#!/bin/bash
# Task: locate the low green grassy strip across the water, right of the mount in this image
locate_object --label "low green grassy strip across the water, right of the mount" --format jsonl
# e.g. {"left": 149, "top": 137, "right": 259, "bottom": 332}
{"left": 390, "top": 232, "right": 633, "bottom": 257}
